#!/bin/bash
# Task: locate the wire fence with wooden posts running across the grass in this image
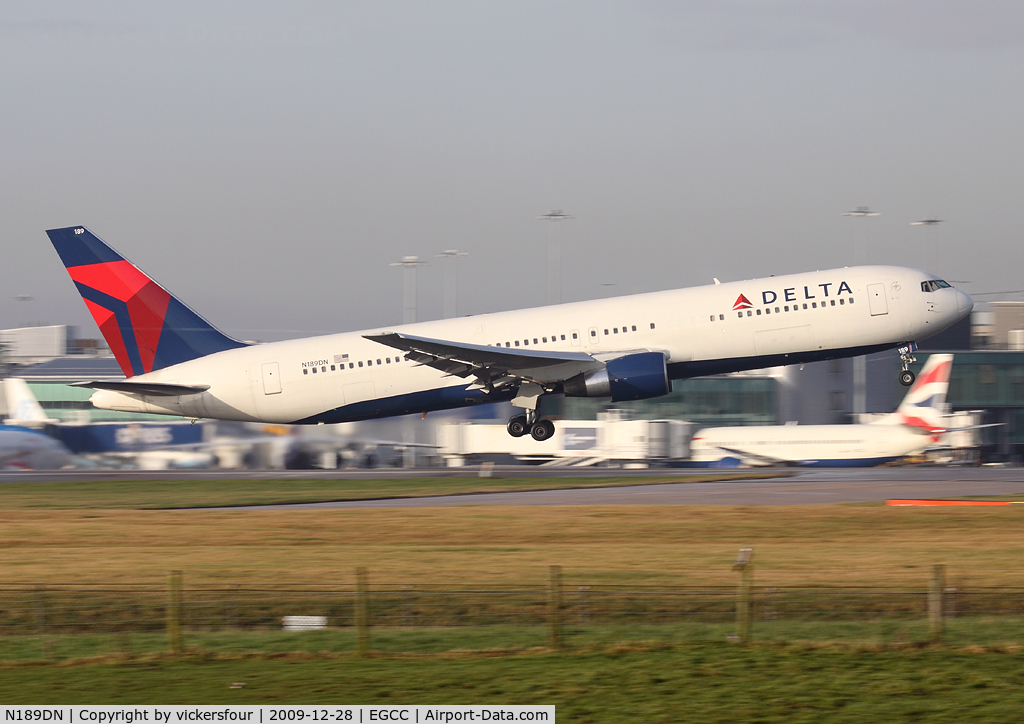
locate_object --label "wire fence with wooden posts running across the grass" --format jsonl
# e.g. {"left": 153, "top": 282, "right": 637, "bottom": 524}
{"left": 0, "top": 566, "right": 1024, "bottom": 662}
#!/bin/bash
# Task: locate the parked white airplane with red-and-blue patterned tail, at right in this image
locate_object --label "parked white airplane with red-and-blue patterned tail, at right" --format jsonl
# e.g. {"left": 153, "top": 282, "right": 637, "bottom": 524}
{"left": 690, "top": 354, "right": 953, "bottom": 467}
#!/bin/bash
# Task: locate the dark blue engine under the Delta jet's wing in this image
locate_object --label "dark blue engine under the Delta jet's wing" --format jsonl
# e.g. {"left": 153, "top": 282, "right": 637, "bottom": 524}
{"left": 562, "top": 352, "right": 672, "bottom": 402}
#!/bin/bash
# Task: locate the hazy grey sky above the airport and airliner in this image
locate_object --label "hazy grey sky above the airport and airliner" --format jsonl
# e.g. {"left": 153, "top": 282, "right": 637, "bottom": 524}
{"left": 0, "top": 0, "right": 1024, "bottom": 341}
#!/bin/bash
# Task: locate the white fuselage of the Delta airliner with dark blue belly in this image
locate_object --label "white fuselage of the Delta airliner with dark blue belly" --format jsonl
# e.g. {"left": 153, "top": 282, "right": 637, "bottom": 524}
{"left": 91, "top": 266, "right": 973, "bottom": 423}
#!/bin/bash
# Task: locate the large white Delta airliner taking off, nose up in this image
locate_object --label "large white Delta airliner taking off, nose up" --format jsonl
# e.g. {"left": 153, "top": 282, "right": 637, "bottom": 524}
{"left": 47, "top": 226, "right": 974, "bottom": 440}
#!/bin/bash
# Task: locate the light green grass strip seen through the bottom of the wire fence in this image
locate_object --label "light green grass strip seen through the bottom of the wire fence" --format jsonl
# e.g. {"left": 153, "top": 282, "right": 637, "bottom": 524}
{"left": 9, "top": 615, "right": 1024, "bottom": 665}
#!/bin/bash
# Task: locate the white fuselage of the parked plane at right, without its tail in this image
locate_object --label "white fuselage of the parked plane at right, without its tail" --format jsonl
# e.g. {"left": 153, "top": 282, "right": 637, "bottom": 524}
{"left": 690, "top": 424, "right": 937, "bottom": 466}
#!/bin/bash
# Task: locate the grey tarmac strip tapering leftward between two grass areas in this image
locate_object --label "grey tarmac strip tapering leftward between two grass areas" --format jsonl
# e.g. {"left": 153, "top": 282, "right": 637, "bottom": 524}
{"left": 222, "top": 468, "right": 1024, "bottom": 510}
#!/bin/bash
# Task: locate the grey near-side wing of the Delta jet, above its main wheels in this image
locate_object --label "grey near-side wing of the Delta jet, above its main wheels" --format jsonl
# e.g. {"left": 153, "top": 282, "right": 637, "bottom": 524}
{"left": 366, "top": 332, "right": 601, "bottom": 389}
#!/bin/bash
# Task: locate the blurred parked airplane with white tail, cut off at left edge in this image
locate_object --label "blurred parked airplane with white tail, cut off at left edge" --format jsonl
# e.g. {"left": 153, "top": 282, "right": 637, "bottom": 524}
{"left": 0, "top": 377, "right": 72, "bottom": 470}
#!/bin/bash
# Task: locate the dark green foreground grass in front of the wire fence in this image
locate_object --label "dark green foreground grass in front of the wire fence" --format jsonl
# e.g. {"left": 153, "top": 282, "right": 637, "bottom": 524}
{"left": 0, "top": 643, "right": 1024, "bottom": 722}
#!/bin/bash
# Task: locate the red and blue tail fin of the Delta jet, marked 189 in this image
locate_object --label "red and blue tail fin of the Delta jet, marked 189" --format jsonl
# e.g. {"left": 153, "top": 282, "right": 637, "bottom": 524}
{"left": 46, "top": 226, "right": 245, "bottom": 377}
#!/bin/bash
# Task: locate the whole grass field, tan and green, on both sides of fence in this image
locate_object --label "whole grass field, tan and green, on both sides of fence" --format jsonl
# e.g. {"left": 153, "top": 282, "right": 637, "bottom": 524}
{"left": 0, "top": 477, "right": 1024, "bottom": 722}
